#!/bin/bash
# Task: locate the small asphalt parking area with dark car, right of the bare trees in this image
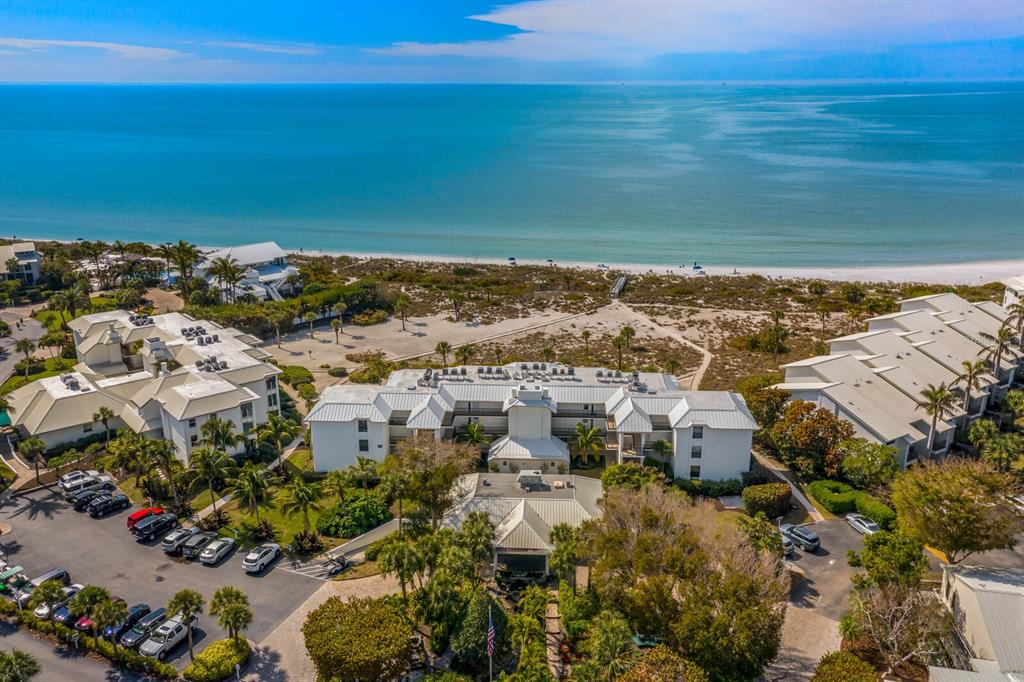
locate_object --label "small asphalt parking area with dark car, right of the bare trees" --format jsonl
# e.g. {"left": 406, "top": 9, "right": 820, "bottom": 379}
{"left": 790, "top": 518, "right": 864, "bottom": 621}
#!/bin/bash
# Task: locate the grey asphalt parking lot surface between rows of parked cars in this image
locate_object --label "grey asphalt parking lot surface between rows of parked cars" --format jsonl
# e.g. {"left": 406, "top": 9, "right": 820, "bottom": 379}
{"left": 0, "top": 487, "right": 323, "bottom": 666}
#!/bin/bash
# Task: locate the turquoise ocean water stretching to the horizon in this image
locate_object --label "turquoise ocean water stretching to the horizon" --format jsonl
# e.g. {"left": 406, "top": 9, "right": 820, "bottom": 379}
{"left": 0, "top": 83, "right": 1024, "bottom": 266}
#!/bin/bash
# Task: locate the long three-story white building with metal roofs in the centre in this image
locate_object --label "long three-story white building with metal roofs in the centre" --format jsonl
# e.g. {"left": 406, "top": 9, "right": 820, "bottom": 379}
{"left": 306, "top": 363, "right": 758, "bottom": 480}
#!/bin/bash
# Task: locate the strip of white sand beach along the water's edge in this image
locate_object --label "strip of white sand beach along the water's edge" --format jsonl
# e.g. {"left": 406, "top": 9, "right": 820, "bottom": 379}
{"left": 16, "top": 237, "right": 1024, "bottom": 285}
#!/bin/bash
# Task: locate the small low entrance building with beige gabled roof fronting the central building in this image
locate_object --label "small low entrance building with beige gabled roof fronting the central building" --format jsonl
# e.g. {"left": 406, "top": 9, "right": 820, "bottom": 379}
{"left": 443, "top": 473, "right": 603, "bottom": 572}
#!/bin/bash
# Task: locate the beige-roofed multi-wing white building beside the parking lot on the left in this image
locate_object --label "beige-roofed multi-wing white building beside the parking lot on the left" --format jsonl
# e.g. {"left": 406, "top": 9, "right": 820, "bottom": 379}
{"left": 9, "top": 310, "right": 281, "bottom": 463}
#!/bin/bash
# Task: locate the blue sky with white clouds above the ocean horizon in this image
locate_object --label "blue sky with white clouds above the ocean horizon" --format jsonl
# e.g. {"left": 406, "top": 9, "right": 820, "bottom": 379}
{"left": 0, "top": 0, "right": 1024, "bottom": 83}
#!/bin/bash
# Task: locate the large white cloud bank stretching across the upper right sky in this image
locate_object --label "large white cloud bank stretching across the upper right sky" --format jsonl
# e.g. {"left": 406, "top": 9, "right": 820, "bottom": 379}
{"left": 369, "top": 0, "right": 1024, "bottom": 62}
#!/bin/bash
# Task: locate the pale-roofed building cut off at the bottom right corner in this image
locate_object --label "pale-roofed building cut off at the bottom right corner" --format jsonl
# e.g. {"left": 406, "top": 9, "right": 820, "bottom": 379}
{"left": 929, "top": 566, "right": 1024, "bottom": 682}
